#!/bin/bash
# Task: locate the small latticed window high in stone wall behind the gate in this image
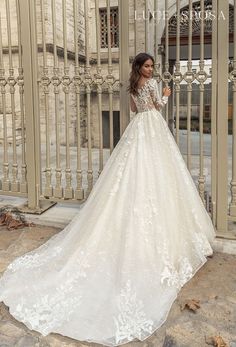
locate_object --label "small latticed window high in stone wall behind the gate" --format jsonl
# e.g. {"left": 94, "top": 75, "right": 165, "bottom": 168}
{"left": 99, "top": 7, "right": 119, "bottom": 48}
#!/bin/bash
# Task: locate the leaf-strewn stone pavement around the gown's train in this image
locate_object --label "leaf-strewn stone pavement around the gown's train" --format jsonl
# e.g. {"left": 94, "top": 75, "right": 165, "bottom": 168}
{"left": 0, "top": 226, "right": 236, "bottom": 347}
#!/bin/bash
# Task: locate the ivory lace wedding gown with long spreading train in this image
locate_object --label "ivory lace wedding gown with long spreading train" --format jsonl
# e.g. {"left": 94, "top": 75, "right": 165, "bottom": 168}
{"left": 0, "top": 78, "right": 215, "bottom": 346}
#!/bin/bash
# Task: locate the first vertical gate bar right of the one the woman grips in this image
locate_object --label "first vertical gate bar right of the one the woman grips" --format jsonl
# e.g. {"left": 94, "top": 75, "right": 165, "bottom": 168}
{"left": 175, "top": 0, "right": 180, "bottom": 146}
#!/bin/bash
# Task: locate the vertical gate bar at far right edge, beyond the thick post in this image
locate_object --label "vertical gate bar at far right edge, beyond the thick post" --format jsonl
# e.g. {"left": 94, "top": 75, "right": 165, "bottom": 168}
{"left": 229, "top": 0, "right": 236, "bottom": 217}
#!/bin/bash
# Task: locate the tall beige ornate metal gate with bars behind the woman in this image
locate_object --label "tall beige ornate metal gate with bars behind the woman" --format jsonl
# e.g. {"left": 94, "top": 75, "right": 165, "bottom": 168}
{"left": 0, "top": 0, "right": 236, "bottom": 237}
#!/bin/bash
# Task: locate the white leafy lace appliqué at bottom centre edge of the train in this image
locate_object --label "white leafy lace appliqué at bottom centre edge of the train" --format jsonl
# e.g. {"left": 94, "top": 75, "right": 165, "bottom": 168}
{"left": 114, "top": 280, "right": 153, "bottom": 343}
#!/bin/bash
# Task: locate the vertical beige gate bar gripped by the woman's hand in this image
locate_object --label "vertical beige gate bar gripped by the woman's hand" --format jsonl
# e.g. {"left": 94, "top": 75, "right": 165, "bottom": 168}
{"left": 163, "top": 0, "right": 169, "bottom": 124}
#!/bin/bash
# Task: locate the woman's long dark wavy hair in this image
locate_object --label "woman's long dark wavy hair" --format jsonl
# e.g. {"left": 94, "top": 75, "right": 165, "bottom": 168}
{"left": 127, "top": 53, "right": 154, "bottom": 95}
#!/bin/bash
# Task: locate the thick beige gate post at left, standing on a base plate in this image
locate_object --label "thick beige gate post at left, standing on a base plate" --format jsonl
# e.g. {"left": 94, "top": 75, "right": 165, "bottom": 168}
{"left": 19, "top": 0, "right": 40, "bottom": 210}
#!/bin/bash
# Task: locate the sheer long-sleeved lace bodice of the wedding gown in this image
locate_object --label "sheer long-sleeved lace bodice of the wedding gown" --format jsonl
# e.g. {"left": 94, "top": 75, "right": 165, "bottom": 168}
{"left": 131, "top": 78, "right": 168, "bottom": 113}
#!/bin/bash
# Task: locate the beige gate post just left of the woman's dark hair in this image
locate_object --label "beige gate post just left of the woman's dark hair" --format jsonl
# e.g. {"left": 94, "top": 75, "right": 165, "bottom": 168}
{"left": 119, "top": 0, "right": 130, "bottom": 134}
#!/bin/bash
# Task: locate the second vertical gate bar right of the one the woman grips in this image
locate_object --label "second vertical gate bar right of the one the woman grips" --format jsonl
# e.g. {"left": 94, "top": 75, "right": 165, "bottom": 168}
{"left": 187, "top": 0, "right": 195, "bottom": 171}
